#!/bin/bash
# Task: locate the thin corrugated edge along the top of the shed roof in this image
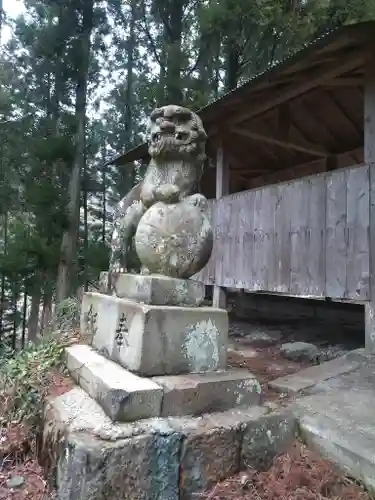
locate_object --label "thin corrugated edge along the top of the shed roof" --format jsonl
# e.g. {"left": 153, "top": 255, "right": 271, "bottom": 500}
{"left": 102, "top": 21, "right": 375, "bottom": 167}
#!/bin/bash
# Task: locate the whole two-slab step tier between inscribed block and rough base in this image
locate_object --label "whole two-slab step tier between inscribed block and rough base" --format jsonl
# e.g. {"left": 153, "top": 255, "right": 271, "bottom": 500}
{"left": 66, "top": 345, "right": 261, "bottom": 422}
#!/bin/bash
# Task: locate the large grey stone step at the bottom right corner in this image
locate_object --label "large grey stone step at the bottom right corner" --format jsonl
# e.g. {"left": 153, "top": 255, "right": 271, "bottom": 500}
{"left": 294, "top": 389, "right": 375, "bottom": 490}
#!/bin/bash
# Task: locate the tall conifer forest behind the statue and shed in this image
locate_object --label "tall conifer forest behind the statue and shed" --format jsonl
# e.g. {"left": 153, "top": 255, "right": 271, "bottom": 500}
{"left": 0, "top": 0, "right": 375, "bottom": 354}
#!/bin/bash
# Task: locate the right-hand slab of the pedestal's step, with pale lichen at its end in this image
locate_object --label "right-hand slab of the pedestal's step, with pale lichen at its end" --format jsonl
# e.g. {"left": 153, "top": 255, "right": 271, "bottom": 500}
{"left": 153, "top": 370, "right": 261, "bottom": 417}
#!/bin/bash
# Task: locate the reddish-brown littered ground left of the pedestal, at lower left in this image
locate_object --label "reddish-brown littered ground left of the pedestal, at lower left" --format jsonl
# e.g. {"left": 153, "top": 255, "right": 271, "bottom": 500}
{"left": 0, "top": 372, "right": 74, "bottom": 500}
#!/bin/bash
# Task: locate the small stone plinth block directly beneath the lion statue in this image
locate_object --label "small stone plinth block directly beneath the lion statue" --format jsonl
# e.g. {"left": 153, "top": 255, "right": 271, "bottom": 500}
{"left": 100, "top": 272, "right": 205, "bottom": 307}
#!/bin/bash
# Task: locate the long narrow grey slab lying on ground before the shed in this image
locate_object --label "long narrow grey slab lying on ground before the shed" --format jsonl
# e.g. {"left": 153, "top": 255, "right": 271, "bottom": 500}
{"left": 268, "top": 355, "right": 360, "bottom": 394}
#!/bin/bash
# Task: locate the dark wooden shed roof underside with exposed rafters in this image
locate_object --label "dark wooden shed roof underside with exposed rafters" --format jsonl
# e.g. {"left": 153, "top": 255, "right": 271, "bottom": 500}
{"left": 107, "top": 21, "right": 375, "bottom": 190}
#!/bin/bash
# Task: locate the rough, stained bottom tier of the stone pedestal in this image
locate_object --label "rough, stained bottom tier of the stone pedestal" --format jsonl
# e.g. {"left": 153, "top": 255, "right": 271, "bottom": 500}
{"left": 39, "top": 387, "right": 296, "bottom": 500}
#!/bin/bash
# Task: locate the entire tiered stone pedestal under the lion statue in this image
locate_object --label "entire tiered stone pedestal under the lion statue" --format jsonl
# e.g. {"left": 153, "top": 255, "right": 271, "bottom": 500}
{"left": 58, "top": 274, "right": 268, "bottom": 500}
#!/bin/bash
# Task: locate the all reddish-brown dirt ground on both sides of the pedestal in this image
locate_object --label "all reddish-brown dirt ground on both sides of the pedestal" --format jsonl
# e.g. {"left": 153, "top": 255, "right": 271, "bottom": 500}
{"left": 0, "top": 322, "right": 364, "bottom": 500}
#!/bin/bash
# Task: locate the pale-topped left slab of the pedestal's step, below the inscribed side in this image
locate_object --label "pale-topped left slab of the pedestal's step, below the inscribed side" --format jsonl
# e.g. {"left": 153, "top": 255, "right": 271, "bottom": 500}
{"left": 66, "top": 345, "right": 163, "bottom": 422}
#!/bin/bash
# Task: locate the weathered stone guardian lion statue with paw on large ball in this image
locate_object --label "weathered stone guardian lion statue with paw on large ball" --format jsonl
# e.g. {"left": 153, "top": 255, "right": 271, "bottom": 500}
{"left": 109, "top": 105, "right": 213, "bottom": 278}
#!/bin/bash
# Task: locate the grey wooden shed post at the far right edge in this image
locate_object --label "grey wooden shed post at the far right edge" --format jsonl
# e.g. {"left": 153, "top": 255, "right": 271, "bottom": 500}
{"left": 364, "top": 52, "right": 375, "bottom": 353}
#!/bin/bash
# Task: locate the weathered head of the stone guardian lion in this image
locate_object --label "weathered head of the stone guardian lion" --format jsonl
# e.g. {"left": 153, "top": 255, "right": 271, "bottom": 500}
{"left": 148, "top": 104, "right": 207, "bottom": 163}
